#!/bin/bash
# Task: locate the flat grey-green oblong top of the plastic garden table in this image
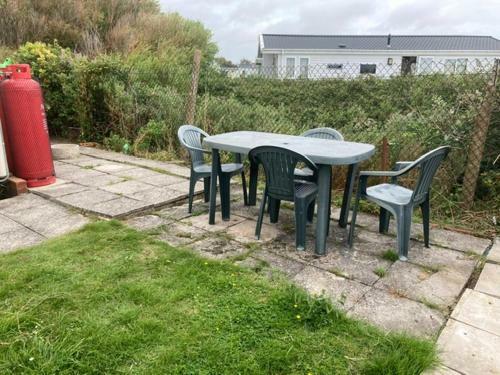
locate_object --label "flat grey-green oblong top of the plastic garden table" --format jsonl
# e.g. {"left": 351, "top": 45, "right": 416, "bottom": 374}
{"left": 203, "top": 131, "right": 375, "bottom": 165}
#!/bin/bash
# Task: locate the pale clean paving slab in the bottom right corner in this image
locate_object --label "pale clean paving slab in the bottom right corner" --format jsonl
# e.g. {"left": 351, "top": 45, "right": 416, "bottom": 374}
{"left": 438, "top": 319, "right": 500, "bottom": 375}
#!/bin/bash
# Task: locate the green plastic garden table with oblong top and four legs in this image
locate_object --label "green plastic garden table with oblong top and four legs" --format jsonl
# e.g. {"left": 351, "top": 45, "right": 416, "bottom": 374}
{"left": 203, "top": 131, "right": 375, "bottom": 255}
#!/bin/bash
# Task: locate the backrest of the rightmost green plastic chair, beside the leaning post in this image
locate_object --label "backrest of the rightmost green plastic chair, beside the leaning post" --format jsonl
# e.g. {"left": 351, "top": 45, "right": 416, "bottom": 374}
{"left": 408, "top": 146, "right": 450, "bottom": 203}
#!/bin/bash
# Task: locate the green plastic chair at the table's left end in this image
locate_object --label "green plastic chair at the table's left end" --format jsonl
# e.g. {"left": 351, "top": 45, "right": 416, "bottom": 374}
{"left": 177, "top": 125, "right": 248, "bottom": 213}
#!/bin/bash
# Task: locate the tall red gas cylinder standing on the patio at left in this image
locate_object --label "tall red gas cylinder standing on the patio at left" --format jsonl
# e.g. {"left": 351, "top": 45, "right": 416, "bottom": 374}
{"left": 0, "top": 64, "right": 56, "bottom": 187}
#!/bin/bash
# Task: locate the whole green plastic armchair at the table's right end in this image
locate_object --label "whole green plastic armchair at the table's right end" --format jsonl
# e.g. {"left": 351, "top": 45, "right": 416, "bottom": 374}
{"left": 348, "top": 146, "right": 450, "bottom": 261}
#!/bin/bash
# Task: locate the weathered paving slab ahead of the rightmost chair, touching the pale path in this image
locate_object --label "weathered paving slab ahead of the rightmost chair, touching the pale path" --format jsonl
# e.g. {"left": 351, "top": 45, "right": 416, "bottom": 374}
{"left": 375, "top": 261, "right": 474, "bottom": 313}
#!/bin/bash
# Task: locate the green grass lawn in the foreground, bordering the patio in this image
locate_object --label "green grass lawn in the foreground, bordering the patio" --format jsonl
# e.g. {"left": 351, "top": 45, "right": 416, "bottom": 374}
{"left": 0, "top": 222, "right": 436, "bottom": 374}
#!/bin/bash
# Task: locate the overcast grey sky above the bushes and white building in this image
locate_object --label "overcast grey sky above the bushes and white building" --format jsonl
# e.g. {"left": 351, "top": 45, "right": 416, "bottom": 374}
{"left": 160, "top": 0, "right": 500, "bottom": 62}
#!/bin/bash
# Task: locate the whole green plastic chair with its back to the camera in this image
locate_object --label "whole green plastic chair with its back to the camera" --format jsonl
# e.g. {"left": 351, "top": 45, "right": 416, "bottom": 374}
{"left": 249, "top": 146, "right": 318, "bottom": 250}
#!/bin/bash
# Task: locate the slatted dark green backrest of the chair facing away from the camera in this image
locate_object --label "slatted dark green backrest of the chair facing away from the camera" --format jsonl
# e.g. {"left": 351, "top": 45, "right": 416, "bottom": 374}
{"left": 248, "top": 146, "right": 318, "bottom": 201}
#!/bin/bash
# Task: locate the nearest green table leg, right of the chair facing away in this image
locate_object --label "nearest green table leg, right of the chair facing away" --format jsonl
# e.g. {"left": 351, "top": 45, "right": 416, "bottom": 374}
{"left": 316, "top": 164, "right": 332, "bottom": 255}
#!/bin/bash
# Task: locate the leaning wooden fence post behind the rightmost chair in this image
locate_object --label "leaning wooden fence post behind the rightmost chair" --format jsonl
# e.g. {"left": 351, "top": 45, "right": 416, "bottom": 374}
{"left": 462, "top": 59, "right": 500, "bottom": 210}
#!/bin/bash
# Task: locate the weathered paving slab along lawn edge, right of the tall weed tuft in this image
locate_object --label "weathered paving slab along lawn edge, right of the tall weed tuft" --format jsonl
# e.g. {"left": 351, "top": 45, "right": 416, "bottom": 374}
{"left": 349, "top": 288, "right": 445, "bottom": 338}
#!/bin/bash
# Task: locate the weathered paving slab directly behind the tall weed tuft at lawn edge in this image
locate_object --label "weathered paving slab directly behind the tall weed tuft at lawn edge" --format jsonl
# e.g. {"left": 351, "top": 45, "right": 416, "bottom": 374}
{"left": 293, "top": 266, "right": 371, "bottom": 310}
